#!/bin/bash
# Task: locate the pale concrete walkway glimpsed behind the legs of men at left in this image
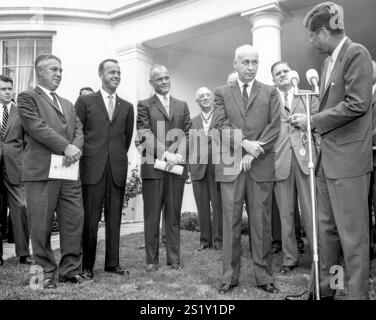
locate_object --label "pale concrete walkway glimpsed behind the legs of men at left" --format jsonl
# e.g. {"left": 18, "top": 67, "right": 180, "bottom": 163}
{"left": 3, "top": 222, "right": 144, "bottom": 260}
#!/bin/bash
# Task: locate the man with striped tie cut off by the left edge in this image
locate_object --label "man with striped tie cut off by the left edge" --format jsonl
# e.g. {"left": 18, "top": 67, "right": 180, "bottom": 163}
{"left": 0, "top": 75, "right": 34, "bottom": 264}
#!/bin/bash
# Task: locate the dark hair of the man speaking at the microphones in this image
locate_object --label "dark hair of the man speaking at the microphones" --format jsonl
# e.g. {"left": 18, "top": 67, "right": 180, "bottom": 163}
{"left": 303, "top": 2, "right": 345, "bottom": 35}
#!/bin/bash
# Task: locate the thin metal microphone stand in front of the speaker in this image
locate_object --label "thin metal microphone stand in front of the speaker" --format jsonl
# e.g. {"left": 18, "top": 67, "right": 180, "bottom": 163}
{"left": 294, "top": 87, "right": 320, "bottom": 300}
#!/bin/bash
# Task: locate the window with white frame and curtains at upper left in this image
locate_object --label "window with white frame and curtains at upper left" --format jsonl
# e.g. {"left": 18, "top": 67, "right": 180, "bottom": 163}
{"left": 0, "top": 38, "right": 52, "bottom": 95}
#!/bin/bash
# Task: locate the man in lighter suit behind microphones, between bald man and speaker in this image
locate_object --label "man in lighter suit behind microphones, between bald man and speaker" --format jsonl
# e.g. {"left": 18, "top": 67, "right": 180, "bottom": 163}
{"left": 271, "top": 61, "right": 318, "bottom": 274}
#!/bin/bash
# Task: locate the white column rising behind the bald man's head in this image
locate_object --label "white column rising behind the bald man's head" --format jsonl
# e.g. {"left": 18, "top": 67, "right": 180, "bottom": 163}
{"left": 242, "top": 4, "right": 285, "bottom": 84}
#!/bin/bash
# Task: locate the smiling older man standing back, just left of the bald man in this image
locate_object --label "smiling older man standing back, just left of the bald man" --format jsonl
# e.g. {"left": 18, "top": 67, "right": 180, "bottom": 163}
{"left": 189, "top": 87, "right": 222, "bottom": 250}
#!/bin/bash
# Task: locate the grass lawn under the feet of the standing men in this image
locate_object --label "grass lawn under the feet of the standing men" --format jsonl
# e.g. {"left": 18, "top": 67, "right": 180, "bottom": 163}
{"left": 0, "top": 230, "right": 376, "bottom": 300}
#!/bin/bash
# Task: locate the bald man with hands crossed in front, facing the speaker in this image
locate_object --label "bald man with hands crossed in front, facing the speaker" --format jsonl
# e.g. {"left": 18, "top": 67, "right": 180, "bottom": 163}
{"left": 213, "top": 45, "right": 281, "bottom": 293}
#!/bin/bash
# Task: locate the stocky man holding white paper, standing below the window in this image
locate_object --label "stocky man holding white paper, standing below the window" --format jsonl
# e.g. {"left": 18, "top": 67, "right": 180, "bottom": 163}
{"left": 17, "top": 55, "right": 84, "bottom": 289}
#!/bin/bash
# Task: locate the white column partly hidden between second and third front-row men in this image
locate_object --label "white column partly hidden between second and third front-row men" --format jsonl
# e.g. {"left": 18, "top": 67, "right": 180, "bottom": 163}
{"left": 116, "top": 44, "right": 155, "bottom": 221}
